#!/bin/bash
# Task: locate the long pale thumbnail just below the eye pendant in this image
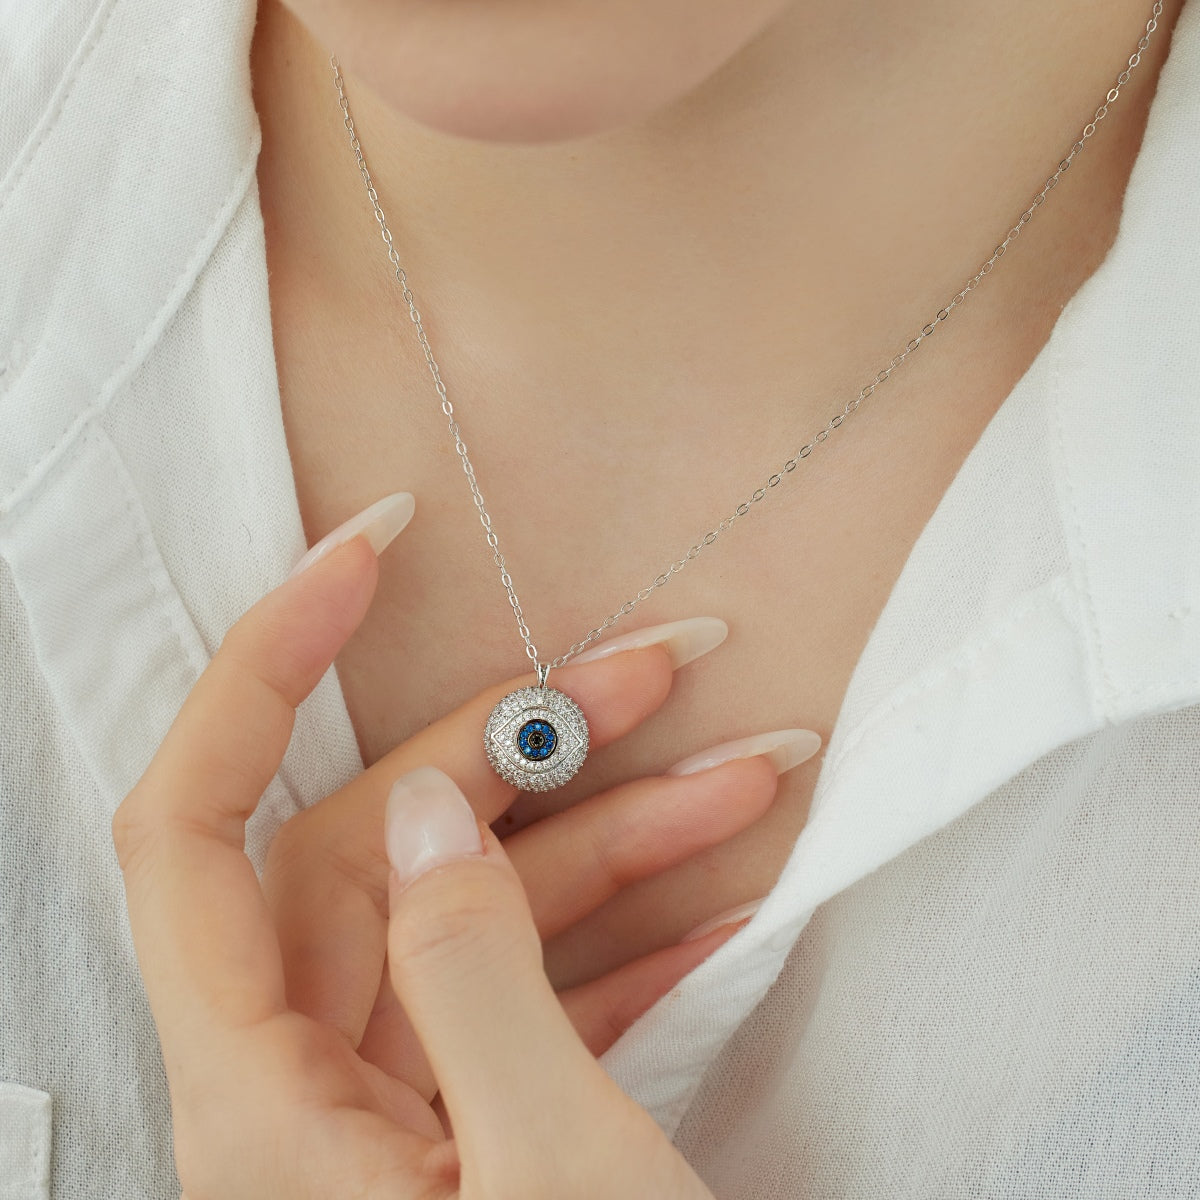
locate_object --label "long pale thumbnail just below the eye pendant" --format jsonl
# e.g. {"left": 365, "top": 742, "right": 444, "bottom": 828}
{"left": 384, "top": 767, "right": 484, "bottom": 884}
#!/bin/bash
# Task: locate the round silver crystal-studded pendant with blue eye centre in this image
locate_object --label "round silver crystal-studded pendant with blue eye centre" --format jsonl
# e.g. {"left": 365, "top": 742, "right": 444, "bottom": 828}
{"left": 484, "top": 686, "right": 588, "bottom": 792}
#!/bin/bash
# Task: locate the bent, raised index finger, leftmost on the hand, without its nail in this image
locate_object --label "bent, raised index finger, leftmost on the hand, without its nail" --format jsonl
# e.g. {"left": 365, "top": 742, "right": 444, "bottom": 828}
{"left": 113, "top": 536, "right": 378, "bottom": 1055}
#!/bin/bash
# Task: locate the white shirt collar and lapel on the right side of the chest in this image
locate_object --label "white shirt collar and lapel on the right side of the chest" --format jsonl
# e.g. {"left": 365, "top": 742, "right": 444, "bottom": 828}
{"left": 605, "top": 4, "right": 1200, "bottom": 1130}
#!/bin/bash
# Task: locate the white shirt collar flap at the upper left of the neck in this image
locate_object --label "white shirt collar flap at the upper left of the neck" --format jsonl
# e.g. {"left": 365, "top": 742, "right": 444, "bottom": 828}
{"left": 0, "top": 0, "right": 259, "bottom": 520}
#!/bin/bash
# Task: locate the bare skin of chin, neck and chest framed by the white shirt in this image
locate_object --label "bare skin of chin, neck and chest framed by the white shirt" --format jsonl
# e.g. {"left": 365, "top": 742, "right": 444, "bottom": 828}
{"left": 252, "top": 0, "right": 1178, "bottom": 985}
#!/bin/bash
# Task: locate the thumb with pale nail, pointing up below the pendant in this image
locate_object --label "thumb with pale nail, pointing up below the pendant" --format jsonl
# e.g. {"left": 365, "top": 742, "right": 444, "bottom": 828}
{"left": 386, "top": 767, "right": 610, "bottom": 1184}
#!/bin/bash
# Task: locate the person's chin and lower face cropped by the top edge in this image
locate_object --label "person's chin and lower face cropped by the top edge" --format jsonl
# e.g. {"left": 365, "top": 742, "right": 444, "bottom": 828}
{"left": 286, "top": 0, "right": 788, "bottom": 143}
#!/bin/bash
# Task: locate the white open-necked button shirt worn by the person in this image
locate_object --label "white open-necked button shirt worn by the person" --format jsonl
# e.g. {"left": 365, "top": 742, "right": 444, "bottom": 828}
{"left": 0, "top": 0, "right": 1200, "bottom": 1200}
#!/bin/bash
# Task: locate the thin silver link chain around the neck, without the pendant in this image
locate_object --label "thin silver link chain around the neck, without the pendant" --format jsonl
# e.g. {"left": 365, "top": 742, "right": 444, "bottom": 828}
{"left": 329, "top": 0, "right": 1163, "bottom": 683}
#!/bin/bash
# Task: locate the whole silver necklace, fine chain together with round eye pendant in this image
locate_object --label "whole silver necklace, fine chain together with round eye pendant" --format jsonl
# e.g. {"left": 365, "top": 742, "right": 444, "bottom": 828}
{"left": 329, "top": 7, "right": 1163, "bottom": 792}
